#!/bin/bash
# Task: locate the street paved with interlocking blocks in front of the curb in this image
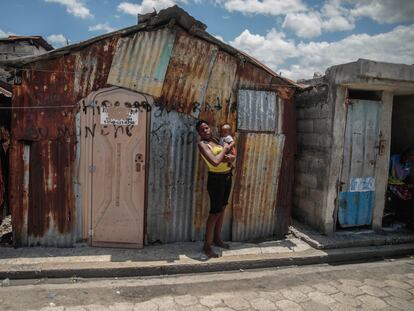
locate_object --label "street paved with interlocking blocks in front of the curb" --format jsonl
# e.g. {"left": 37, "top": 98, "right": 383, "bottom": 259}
{"left": 0, "top": 259, "right": 414, "bottom": 311}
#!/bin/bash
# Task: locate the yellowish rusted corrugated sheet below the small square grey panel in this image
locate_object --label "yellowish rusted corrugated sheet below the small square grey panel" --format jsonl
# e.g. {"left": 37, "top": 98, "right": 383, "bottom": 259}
{"left": 232, "top": 133, "right": 285, "bottom": 241}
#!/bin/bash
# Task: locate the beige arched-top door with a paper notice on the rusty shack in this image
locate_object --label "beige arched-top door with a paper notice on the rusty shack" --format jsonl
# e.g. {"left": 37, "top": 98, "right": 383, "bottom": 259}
{"left": 86, "top": 88, "right": 151, "bottom": 248}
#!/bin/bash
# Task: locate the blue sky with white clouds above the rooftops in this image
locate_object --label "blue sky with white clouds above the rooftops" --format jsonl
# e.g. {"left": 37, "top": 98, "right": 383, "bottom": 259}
{"left": 0, "top": 0, "right": 414, "bottom": 79}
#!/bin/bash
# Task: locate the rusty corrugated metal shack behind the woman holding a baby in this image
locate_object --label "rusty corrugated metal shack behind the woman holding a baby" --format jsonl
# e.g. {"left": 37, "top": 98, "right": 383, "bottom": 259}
{"left": 0, "top": 6, "right": 297, "bottom": 247}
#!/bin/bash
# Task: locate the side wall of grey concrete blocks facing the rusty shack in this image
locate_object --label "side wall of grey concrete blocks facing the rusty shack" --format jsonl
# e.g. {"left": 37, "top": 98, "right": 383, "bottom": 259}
{"left": 292, "top": 83, "right": 333, "bottom": 230}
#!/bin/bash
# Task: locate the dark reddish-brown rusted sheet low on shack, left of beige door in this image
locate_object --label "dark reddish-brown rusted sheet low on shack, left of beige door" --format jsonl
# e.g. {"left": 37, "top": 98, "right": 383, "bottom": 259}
{"left": 27, "top": 140, "right": 76, "bottom": 246}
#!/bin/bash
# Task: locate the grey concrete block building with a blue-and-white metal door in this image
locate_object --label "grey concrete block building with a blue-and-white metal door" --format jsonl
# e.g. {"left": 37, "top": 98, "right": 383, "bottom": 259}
{"left": 293, "top": 59, "right": 414, "bottom": 234}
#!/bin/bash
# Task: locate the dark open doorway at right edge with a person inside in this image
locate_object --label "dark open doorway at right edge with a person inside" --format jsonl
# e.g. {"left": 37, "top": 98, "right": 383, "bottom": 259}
{"left": 382, "top": 95, "right": 414, "bottom": 229}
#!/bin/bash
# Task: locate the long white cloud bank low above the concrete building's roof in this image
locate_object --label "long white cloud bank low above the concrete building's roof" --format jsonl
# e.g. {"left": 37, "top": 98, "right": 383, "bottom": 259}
{"left": 230, "top": 24, "right": 414, "bottom": 79}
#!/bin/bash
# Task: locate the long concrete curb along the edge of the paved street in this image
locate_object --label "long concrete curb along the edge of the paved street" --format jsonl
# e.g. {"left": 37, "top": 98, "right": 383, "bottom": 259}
{"left": 0, "top": 244, "right": 414, "bottom": 279}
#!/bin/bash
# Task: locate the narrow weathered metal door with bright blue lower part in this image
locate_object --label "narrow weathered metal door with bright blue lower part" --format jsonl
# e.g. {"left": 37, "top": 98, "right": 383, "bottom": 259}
{"left": 338, "top": 100, "right": 383, "bottom": 227}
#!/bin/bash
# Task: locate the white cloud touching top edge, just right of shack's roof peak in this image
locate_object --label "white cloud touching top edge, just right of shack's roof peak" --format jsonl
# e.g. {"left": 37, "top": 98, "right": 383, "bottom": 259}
{"left": 216, "top": 0, "right": 306, "bottom": 16}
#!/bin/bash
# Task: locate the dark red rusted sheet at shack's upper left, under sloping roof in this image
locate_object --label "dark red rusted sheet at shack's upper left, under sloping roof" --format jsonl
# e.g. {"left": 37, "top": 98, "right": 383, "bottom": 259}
{"left": 12, "top": 57, "right": 76, "bottom": 141}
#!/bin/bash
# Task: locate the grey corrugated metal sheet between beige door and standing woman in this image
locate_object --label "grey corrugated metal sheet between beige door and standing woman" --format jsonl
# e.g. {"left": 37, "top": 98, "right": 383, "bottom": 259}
{"left": 146, "top": 107, "right": 197, "bottom": 243}
